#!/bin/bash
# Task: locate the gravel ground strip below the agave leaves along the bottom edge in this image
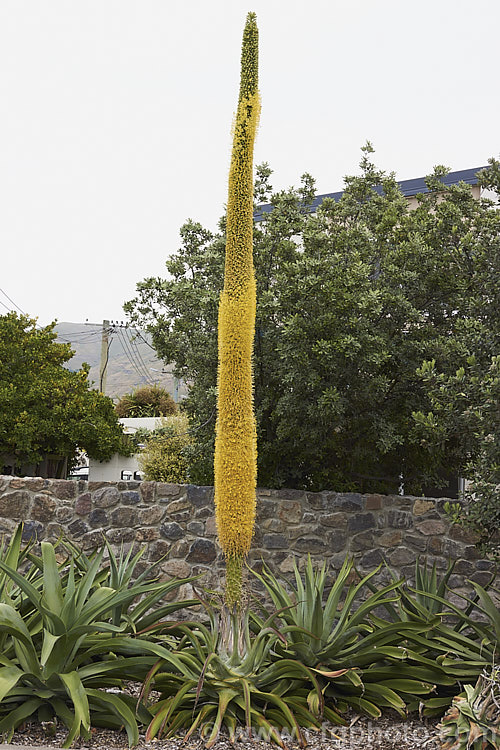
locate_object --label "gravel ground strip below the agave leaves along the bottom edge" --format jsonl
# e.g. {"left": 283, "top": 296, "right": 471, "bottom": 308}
{"left": 4, "top": 714, "right": 440, "bottom": 750}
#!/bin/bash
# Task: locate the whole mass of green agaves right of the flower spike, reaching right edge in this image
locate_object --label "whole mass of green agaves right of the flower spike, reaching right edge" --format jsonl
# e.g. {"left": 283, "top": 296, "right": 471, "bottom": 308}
{"left": 254, "top": 560, "right": 500, "bottom": 718}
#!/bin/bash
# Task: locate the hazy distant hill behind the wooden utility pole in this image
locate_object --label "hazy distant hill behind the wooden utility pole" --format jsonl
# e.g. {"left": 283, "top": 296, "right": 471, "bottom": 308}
{"left": 54, "top": 323, "right": 186, "bottom": 400}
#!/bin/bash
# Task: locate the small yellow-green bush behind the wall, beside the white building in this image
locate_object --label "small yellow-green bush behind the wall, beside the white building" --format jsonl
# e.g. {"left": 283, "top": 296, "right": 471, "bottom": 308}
{"left": 134, "top": 414, "right": 192, "bottom": 483}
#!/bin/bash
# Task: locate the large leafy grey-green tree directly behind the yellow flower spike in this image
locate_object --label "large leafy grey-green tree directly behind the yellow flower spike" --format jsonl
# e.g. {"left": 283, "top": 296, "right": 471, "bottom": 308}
{"left": 125, "top": 150, "right": 500, "bottom": 492}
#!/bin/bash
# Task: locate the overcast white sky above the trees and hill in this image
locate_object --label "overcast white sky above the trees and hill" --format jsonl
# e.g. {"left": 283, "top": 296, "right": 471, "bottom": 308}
{"left": 0, "top": 0, "right": 500, "bottom": 324}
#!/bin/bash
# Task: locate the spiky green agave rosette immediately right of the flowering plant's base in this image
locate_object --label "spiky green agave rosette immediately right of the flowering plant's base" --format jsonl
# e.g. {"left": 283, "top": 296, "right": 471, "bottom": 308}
{"left": 252, "top": 558, "right": 440, "bottom": 718}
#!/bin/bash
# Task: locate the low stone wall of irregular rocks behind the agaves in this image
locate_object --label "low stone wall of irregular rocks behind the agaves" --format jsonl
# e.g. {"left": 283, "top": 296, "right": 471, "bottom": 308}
{"left": 0, "top": 476, "right": 494, "bottom": 608}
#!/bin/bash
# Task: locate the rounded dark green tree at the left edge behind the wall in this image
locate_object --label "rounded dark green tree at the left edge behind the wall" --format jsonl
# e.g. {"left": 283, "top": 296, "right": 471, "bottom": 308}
{"left": 0, "top": 313, "right": 131, "bottom": 467}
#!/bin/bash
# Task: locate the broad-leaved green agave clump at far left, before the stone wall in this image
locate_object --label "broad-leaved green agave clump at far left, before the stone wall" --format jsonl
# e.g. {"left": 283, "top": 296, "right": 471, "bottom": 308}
{"left": 0, "top": 530, "right": 197, "bottom": 747}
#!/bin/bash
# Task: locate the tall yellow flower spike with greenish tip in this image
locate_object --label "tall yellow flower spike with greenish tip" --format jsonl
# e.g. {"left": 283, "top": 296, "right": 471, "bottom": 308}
{"left": 215, "top": 13, "right": 260, "bottom": 607}
